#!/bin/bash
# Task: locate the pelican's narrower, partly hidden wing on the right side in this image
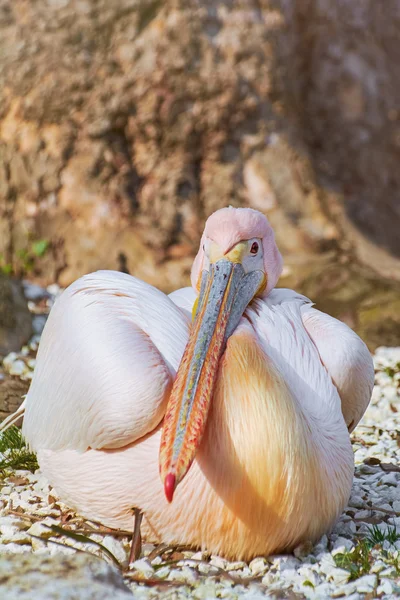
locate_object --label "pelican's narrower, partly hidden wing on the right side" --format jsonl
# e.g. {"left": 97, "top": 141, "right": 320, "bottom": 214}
{"left": 302, "top": 305, "right": 374, "bottom": 431}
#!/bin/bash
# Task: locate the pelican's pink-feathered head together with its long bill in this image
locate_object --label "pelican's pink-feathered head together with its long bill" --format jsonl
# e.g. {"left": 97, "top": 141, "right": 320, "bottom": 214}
{"left": 160, "top": 208, "right": 282, "bottom": 501}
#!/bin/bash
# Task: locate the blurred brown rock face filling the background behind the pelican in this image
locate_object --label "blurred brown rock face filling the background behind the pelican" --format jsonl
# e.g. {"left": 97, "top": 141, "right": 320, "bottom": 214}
{"left": 0, "top": 0, "right": 400, "bottom": 354}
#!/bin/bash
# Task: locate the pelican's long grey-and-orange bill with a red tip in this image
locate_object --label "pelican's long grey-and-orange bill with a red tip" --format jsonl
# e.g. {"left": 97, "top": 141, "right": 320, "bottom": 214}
{"left": 160, "top": 258, "right": 265, "bottom": 502}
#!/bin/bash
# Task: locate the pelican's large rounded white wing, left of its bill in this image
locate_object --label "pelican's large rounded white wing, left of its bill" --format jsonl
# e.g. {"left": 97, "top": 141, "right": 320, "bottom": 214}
{"left": 23, "top": 271, "right": 189, "bottom": 451}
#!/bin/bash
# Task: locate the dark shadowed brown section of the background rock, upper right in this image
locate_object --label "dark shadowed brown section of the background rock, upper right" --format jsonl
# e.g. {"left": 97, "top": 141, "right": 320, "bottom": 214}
{"left": 279, "top": 0, "right": 400, "bottom": 280}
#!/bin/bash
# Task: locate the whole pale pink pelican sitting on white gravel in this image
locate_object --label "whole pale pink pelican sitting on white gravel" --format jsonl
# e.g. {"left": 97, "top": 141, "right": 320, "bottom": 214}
{"left": 1, "top": 207, "right": 374, "bottom": 560}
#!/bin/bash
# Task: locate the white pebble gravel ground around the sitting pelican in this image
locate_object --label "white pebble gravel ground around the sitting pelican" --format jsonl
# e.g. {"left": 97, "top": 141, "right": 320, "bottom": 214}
{"left": 0, "top": 287, "right": 400, "bottom": 600}
